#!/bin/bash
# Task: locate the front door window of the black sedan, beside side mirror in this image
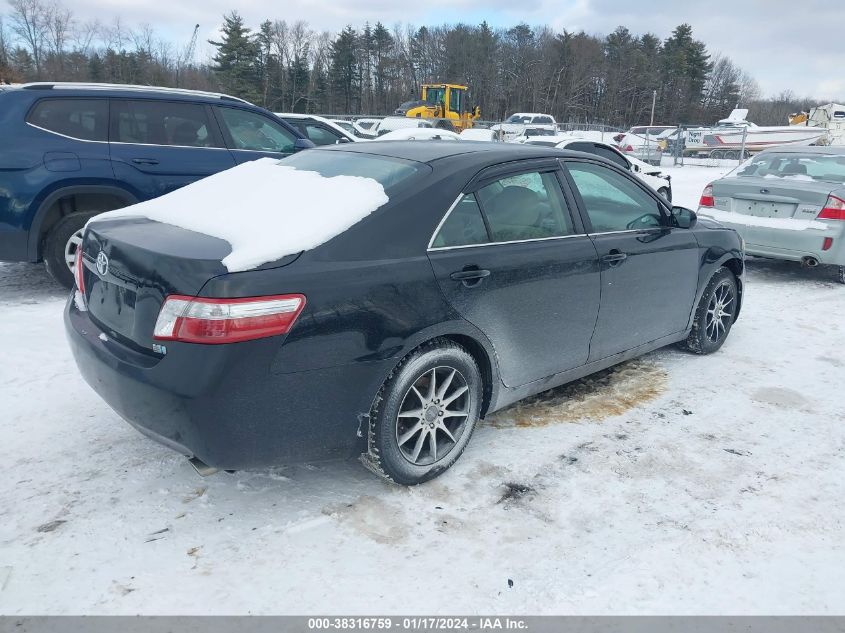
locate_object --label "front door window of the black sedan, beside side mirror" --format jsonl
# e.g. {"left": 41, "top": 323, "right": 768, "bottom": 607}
{"left": 567, "top": 163, "right": 662, "bottom": 233}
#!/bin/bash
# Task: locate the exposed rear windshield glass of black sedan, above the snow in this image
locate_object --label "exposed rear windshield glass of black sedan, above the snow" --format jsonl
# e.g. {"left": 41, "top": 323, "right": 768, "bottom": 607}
{"left": 279, "top": 150, "right": 425, "bottom": 193}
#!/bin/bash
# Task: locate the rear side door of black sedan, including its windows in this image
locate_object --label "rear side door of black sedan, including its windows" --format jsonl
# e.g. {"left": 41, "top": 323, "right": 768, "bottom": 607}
{"left": 428, "top": 162, "right": 600, "bottom": 387}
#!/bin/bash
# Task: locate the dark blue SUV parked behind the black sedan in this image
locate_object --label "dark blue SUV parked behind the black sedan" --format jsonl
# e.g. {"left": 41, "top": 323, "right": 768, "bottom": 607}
{"left": 0, "top": 83, "right": 313, "bottom": 288}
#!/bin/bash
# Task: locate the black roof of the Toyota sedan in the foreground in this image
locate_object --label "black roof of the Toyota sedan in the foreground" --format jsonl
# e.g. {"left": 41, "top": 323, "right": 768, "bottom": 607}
{"left": 310, "top": 140, "right": 583, "bottom": 166}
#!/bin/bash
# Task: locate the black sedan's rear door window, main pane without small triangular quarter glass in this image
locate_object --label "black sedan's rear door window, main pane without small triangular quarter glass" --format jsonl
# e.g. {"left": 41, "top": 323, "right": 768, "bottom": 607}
{"left": 478, "top": 171, "right": 573, "bottom": 242}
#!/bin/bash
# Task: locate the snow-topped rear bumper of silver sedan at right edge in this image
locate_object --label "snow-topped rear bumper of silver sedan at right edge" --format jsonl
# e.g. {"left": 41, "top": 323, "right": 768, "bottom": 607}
{"left": 698, "top": 208, "right": 845, "bottom": 266}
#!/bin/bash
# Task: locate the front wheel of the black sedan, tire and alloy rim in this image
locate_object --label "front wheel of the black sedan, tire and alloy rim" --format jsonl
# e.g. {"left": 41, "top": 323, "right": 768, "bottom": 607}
{"left": 681, "top": 267, "right": 739, "bottom": 354}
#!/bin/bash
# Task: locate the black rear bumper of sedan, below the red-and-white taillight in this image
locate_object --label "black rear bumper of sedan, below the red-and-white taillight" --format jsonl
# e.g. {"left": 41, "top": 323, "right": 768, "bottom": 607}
{"left": 64, "top": 298, "right": 392, "bottom": 470}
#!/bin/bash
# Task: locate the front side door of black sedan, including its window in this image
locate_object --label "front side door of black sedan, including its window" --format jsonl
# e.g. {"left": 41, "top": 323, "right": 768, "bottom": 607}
{"left": 565, "top": 160, "right": 699, "bottom": 361}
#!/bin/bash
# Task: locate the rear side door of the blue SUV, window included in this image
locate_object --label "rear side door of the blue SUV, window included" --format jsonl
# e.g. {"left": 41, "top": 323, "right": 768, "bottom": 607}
{"left": 109, "top": 99, "right": 235, "bottom": 199}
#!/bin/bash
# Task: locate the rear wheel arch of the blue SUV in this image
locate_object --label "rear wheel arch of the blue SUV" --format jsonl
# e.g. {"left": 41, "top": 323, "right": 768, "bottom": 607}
{"left": 27, "top": 184, "right": 140, "bottom": 261}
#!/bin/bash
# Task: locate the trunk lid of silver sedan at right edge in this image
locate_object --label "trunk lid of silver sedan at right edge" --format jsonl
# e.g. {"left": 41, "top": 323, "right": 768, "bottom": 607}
{"left": 713, "top": 176, "right": 835, "bottom": 220}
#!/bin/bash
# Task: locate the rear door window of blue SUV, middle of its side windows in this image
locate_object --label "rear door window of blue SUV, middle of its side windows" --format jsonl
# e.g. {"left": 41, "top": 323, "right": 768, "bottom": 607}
{"left": 112, "top": 99, "right": 222, "bottom": 147}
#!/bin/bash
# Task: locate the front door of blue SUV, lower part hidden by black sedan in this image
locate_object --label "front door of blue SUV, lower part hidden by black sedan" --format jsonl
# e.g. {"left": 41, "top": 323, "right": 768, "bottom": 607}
{"left": 214, "top": 106, "right": 297, "bottom": 164}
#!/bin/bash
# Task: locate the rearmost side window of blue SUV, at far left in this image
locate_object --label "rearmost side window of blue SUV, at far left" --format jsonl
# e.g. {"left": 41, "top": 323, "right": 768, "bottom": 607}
{"left": 27, "top": 99, "right": 109, "bottom": 141}
